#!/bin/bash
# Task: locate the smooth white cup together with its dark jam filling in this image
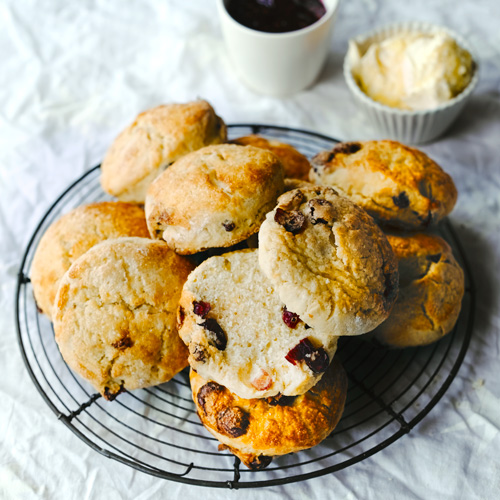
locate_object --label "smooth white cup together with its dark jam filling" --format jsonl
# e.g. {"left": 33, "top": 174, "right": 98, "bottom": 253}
{"left": 217, "top": 0, "right": 338, "bottom": 97}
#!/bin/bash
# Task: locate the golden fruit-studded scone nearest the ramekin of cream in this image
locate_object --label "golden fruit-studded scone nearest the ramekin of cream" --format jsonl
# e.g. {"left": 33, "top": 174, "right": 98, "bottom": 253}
{"left": 310, "top": 141, "right": 457, "bottom": 230}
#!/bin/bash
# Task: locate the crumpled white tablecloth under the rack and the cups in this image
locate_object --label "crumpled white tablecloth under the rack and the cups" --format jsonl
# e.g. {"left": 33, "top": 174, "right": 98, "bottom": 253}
{"left": 0, "top": 0, "right": 500, "bottom": 500}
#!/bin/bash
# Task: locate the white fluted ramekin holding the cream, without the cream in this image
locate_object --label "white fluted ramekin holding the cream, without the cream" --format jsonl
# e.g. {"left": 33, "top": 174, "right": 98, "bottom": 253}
{"left": 344, "top": 22, "right": 479, "bottom": 144}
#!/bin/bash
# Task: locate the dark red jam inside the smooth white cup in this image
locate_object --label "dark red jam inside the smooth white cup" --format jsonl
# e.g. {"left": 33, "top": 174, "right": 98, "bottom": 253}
{"left": 226, "top": 0, "right": 326, "bottom": 33}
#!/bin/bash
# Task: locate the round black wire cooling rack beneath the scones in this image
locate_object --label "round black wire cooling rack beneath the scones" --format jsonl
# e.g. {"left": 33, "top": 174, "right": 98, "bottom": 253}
{"left": 16, "top": 124, "right": 475, "bottom": 488}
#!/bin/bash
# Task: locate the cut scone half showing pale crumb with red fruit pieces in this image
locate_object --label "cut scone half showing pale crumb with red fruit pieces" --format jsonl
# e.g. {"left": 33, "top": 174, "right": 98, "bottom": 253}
{"left": 178, "top": 249, "right": 337, "bottom": 398}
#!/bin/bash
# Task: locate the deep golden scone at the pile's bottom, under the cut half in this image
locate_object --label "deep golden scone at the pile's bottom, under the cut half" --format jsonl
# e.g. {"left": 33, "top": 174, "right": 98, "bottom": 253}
{"left": 190, "top": 358, "right": 347, "bottom": 470}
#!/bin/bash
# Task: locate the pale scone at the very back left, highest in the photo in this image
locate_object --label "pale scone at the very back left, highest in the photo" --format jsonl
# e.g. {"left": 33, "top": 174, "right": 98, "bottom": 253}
{"left": 101, "top": 100, "right": 227, "bottom": 203}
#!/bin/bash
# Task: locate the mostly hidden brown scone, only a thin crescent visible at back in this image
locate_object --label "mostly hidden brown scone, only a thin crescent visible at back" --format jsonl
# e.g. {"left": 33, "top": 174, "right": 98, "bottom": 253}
{"left": 231, "top": 134, "right": 311, "bottom": 181}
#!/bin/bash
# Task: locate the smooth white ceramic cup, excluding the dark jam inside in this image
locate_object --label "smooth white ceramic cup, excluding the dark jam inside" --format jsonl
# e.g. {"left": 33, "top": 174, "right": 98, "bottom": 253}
{"left": 217, "top": 0, "right": 339, "bottom": 97}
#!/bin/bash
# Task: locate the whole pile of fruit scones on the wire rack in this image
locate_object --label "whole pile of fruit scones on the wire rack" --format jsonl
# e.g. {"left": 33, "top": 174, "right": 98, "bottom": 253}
{"left": 31, "top": 101, "right": 463, "bottom": 469}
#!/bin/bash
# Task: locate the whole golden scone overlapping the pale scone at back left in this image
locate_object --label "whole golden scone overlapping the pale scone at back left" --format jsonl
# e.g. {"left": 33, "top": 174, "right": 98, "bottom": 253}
{"left": 145, "top": 144, "right": 284, "bottom": 254}
